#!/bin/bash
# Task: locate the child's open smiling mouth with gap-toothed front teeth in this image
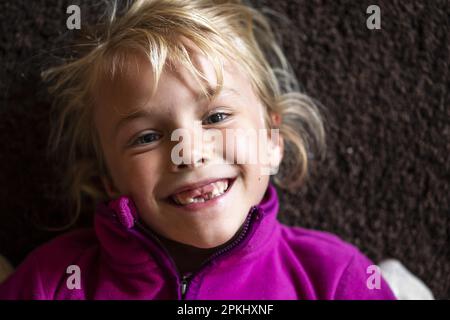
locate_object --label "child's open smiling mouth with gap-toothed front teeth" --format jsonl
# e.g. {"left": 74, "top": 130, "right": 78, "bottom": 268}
{"left": 169, "top": 178, "right": 235, "bottom": 206}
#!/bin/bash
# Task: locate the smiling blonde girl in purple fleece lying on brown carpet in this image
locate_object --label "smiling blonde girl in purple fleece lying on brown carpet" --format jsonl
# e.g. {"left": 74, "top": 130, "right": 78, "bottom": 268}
{"left": 0, "top": 0, "right": 394, "bottom": 299}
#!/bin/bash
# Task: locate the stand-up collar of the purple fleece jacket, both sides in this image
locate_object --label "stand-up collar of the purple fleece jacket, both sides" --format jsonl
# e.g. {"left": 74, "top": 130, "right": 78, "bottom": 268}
{"left": 94, "top": 183, "right": 279, "bottom": 265}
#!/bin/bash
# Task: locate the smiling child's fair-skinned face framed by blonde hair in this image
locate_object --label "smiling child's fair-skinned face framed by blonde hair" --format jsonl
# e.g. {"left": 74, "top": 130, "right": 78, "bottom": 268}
{"left": 94, "top": 45, "right": 280, "bottom": 248}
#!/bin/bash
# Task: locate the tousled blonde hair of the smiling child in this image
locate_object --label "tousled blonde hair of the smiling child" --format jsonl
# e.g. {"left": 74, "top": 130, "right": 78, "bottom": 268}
{"left": 42, "top": 0, "right": 325, "bottom": 230}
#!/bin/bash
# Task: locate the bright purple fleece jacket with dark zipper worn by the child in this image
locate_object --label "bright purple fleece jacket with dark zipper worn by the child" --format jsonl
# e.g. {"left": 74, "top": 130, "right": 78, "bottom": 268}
{"left": 0, "top": 185, "right": 395, "bottom": 299}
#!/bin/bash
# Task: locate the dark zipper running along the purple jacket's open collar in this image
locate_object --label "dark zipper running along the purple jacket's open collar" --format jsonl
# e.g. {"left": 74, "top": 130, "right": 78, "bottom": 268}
{"left": 135, "top": 206, "right": 257, "bottom": 300}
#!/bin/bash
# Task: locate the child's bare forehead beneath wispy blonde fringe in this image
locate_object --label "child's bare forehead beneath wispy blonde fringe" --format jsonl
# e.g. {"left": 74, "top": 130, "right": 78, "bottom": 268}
{"left": 94, "top": 43, "right": 254, "bottom": 114}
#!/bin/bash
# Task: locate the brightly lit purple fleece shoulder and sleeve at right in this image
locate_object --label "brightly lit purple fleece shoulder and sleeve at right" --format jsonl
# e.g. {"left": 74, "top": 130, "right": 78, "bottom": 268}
{"left": 280, "top": 225, "right": 395, "bottom": 299}
